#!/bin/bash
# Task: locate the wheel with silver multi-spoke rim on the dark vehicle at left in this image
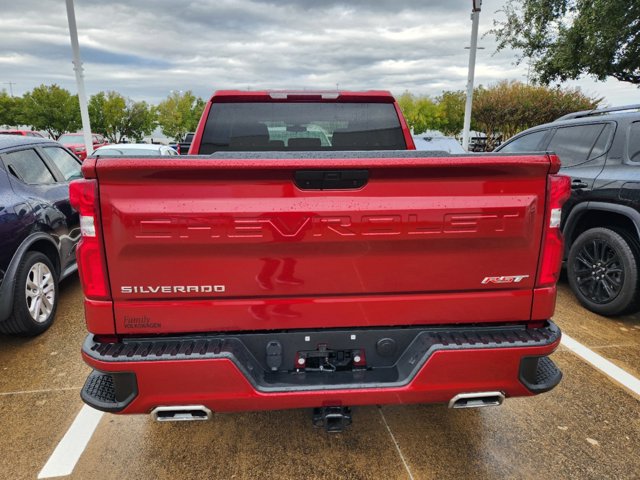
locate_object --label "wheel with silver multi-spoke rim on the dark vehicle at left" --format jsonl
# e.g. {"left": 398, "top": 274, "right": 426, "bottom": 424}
{"left": 0, "top": 252, "right": 58, "bottom": 336}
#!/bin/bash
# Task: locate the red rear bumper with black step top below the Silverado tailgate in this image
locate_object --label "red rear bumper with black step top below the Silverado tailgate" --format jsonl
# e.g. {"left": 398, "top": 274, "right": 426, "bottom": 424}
{"left": 82, "top": 321, "right": 562, "bottom": 413}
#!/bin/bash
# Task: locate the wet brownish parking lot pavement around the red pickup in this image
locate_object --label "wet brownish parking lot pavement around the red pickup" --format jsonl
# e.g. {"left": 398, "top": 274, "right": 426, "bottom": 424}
{"left": 0, "top": 276, "right": 640, "bottom": 480}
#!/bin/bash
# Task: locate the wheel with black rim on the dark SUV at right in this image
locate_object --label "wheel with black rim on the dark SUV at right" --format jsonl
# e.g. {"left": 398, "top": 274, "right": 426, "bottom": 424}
{"left": 567, "top": 228, "right": 640, "bottom": 316}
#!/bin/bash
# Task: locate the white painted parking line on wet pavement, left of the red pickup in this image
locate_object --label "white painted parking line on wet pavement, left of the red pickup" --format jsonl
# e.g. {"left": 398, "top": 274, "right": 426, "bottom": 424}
{"left": 38, "top": 405, "right": 103, "bottom": 478}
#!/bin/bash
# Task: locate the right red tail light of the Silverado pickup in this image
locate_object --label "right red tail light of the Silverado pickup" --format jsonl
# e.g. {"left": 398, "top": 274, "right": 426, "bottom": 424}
{"left": 536, "top": 175, "right": 571, "bottom": 288}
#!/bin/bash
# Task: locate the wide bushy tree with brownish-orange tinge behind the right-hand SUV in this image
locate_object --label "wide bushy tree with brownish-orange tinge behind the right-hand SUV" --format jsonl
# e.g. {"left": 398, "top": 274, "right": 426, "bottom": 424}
{"left": 471, "top": 81, "right": 602, "bottom": 150}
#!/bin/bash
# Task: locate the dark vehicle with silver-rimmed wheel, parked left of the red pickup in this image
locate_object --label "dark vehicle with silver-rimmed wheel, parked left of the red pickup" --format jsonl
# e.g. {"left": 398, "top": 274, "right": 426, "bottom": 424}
{"left": 0, "top": 135, "right": 82, "bottom": 335}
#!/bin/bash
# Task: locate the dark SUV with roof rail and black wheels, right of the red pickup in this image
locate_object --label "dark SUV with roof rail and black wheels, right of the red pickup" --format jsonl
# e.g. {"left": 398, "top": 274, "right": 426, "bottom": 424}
{"left": 496, "top": 105, "right": 640, "bottom": 315}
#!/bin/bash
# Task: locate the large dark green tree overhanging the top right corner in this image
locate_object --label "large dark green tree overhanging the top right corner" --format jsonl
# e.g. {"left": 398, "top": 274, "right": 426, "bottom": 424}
{"left": 490, "top": 0, "right": 640, "bottom": 85}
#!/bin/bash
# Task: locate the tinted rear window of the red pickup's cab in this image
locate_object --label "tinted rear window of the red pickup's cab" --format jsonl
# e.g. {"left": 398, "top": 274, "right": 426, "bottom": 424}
{"left": 200, "top": 102, "right": 407, "bottom": 154}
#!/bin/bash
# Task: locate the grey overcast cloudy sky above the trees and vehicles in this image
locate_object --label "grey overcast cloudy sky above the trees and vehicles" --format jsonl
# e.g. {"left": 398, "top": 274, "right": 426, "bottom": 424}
{"left": 0, "top": 0, "right": 640, "bottom": 105}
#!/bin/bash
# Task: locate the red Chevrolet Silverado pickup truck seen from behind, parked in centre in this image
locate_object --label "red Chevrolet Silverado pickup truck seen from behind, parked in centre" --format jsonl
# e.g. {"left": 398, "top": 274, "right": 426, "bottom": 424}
{"left": 71, "top": 91, "right": 569, "bottom": 431}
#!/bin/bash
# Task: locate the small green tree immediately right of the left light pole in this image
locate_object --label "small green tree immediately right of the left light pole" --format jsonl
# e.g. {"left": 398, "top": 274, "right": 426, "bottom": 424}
{"left": 89, "top": 91, "right": 156, "bottom": 143}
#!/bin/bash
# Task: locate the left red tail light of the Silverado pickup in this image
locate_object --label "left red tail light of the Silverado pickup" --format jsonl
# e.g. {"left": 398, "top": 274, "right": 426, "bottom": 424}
{"left": 69, "top": 180, "right": 110, "bottom": 300}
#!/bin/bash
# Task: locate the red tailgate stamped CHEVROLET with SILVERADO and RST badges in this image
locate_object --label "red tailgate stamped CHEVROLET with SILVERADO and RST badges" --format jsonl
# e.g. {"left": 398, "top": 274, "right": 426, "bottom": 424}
{"left": 95, "top": 152, "right": 550, "bottom": 334}
